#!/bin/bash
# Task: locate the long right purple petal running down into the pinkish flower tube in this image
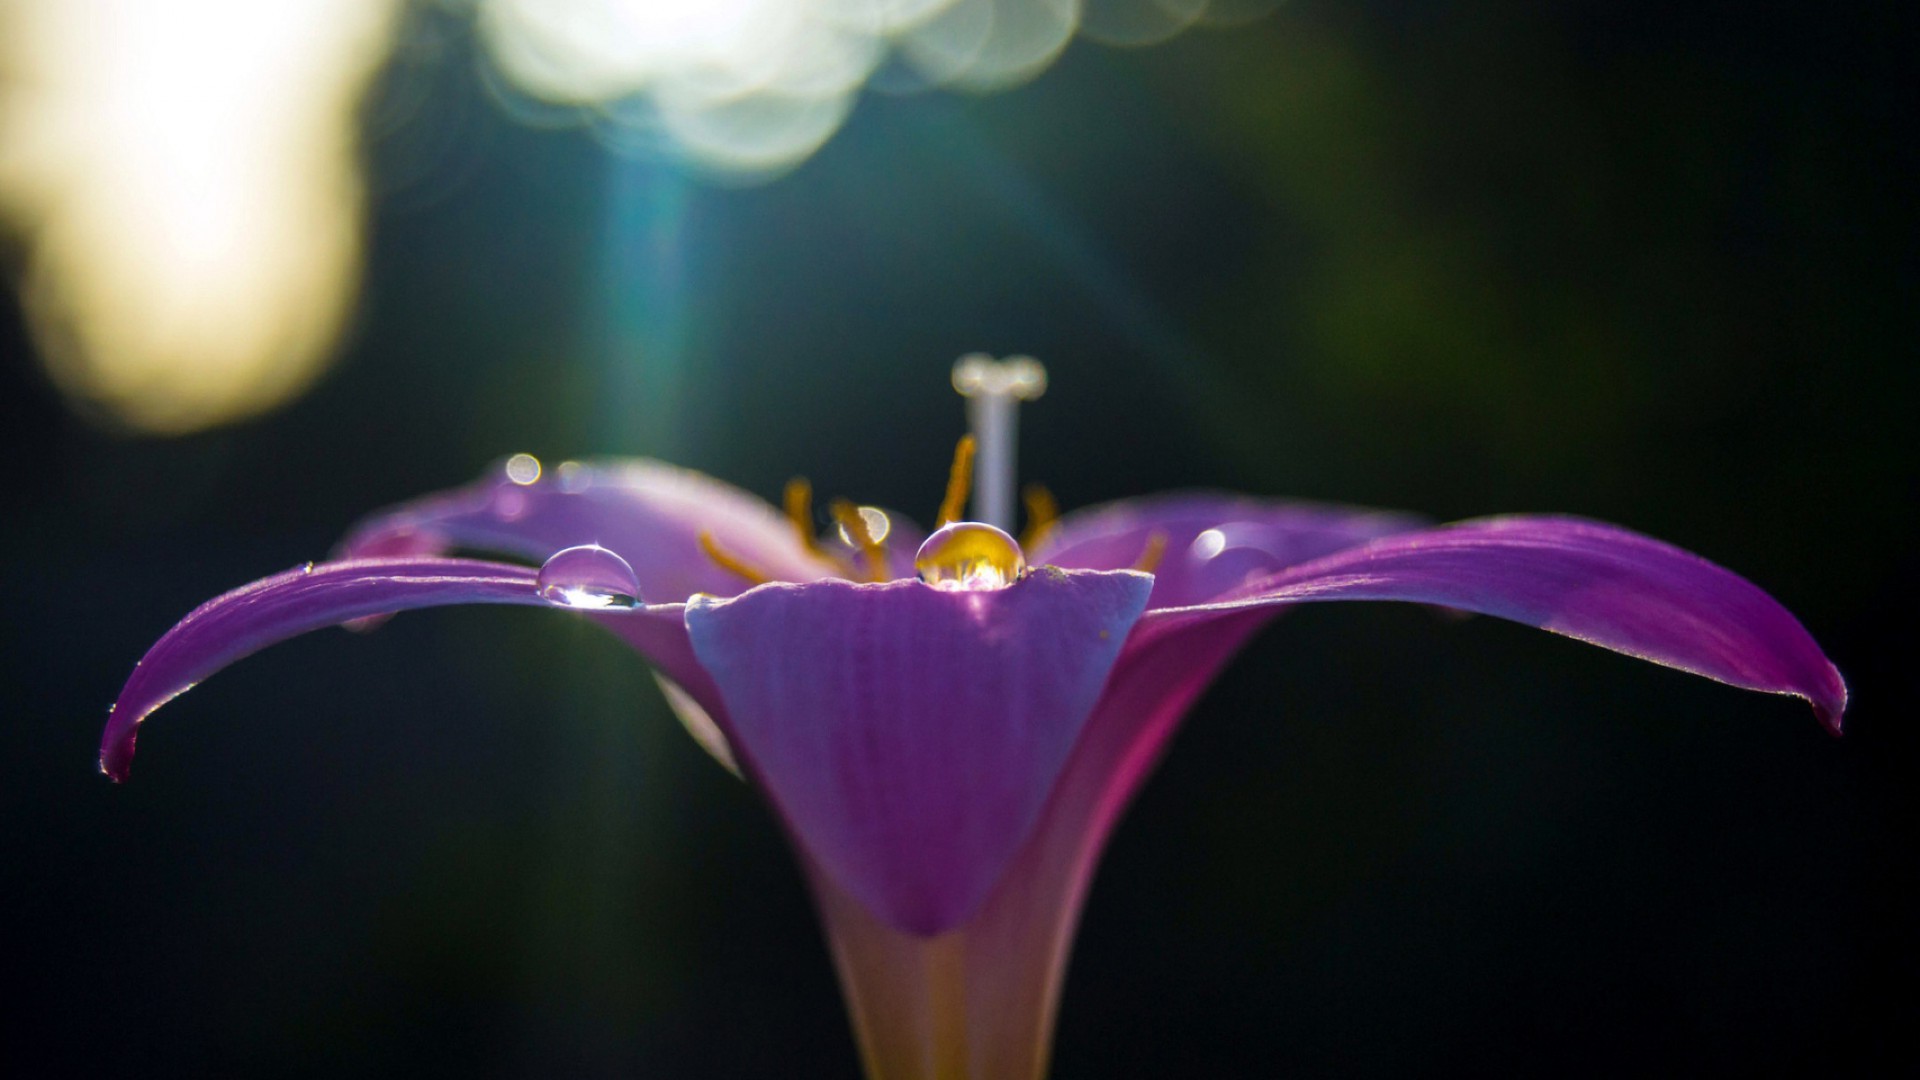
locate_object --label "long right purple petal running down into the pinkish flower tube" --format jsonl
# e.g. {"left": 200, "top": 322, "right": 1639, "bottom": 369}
{"left": 812, "top": 519, "right": 1845, "bottom": 1078}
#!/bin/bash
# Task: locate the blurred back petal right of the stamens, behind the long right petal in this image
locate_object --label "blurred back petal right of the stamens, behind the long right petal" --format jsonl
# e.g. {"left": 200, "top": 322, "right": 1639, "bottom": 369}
{"left": 1027, "top": 492, "right": 1427, "bottom": 607}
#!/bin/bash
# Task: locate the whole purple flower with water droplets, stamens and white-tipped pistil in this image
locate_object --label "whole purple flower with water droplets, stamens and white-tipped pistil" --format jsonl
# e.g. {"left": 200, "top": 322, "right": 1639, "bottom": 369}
{"left": 100, "top": 359, "right": 1847, "bottom": 1078}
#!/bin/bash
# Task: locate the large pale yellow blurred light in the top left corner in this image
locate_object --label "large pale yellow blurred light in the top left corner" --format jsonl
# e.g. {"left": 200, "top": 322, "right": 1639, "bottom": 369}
{"left": 0, "top": 0, "right": 397, "bottom": 432}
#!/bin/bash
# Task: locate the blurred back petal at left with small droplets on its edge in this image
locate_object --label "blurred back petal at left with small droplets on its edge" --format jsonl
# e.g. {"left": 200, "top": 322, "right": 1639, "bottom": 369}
{"left": 340, "top": 459, "right": 839, "bottom": 601}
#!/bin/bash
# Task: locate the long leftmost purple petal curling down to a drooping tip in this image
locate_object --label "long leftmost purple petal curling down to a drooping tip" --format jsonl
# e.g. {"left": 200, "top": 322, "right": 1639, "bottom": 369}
{"left": 100, "top": 557, "right": 710, "bottom": 780}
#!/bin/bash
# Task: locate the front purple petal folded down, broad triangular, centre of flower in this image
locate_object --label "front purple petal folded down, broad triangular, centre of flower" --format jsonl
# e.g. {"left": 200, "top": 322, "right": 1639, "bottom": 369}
{"left": 687, "top": 569, "right": 1152, "bottom": 936}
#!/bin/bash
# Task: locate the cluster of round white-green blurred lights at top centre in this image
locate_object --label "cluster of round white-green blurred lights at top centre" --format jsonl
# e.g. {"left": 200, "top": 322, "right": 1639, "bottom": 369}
{"left": 480, "top": 0, "right": 1277, "bottom": 181}
